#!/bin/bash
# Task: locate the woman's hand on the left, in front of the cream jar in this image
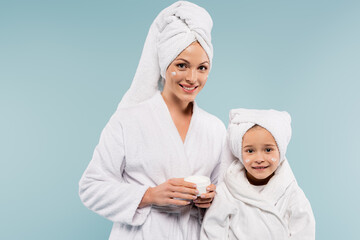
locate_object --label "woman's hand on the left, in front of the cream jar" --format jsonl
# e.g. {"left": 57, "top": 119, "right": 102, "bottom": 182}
{"left": 139, "top": 178, "right": 198, "bottom": 208}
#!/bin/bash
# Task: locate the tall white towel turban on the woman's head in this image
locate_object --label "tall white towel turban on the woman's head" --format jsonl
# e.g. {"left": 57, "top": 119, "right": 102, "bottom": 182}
{"left": 119, "top": 1, "right": 213, "bottom": 107}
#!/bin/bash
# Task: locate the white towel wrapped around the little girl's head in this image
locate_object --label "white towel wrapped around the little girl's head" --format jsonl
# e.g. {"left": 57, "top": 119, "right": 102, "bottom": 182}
{"left": 228, "top": 108, "right": 291, "bottom": 163}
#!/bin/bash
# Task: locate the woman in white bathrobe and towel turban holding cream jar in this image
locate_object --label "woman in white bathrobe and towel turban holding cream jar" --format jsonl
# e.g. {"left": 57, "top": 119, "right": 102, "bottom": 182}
{"left": 79, "top": 1, "right": 226, "bottom": 239}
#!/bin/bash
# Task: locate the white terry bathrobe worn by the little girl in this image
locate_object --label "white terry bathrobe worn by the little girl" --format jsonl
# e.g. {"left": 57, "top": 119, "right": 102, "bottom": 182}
{"left": 200, "top": 159, "right": 315, "bottom": 240}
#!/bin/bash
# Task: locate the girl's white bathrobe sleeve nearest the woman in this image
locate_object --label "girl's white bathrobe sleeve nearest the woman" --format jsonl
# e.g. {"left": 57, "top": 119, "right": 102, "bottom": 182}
{"left": 200, "top": 184, "right": 236, "bottom": 240}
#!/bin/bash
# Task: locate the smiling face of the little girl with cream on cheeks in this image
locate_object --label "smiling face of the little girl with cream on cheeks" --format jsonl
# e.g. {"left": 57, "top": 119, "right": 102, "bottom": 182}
{"left": 242, "top": 126, "right": 280, "bottom": 185}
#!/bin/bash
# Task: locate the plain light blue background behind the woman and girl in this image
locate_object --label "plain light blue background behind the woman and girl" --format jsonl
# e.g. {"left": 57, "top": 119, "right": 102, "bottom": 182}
{"left": 0, "top": 0, "right": 360, "bottom": 240}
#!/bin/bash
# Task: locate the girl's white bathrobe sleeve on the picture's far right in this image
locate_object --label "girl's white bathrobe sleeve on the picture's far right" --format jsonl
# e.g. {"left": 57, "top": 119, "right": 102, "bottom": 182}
{"left": 289, "top": 188, "right": 315, "bottom": 240}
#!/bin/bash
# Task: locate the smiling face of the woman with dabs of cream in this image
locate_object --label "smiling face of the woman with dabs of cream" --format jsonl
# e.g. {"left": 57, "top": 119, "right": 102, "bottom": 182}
{"left": 162, "top": 42, "right": 210, "bottom": 103}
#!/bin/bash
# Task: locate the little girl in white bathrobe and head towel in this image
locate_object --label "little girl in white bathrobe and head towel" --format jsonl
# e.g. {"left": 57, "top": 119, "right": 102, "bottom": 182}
{"left": 201, "top": 109, "right": 315, "bottom": 240}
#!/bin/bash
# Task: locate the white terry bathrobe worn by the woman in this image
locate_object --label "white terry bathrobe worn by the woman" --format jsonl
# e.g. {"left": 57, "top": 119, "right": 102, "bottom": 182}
{"left": 79, "top": 93, "right": 226, "bottom": 240}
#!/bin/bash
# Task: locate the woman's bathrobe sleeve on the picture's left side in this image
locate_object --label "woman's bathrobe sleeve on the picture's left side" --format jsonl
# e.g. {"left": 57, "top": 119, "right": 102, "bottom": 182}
{"left": 79, "top": 113, "right": 150, "bottom": 226}
